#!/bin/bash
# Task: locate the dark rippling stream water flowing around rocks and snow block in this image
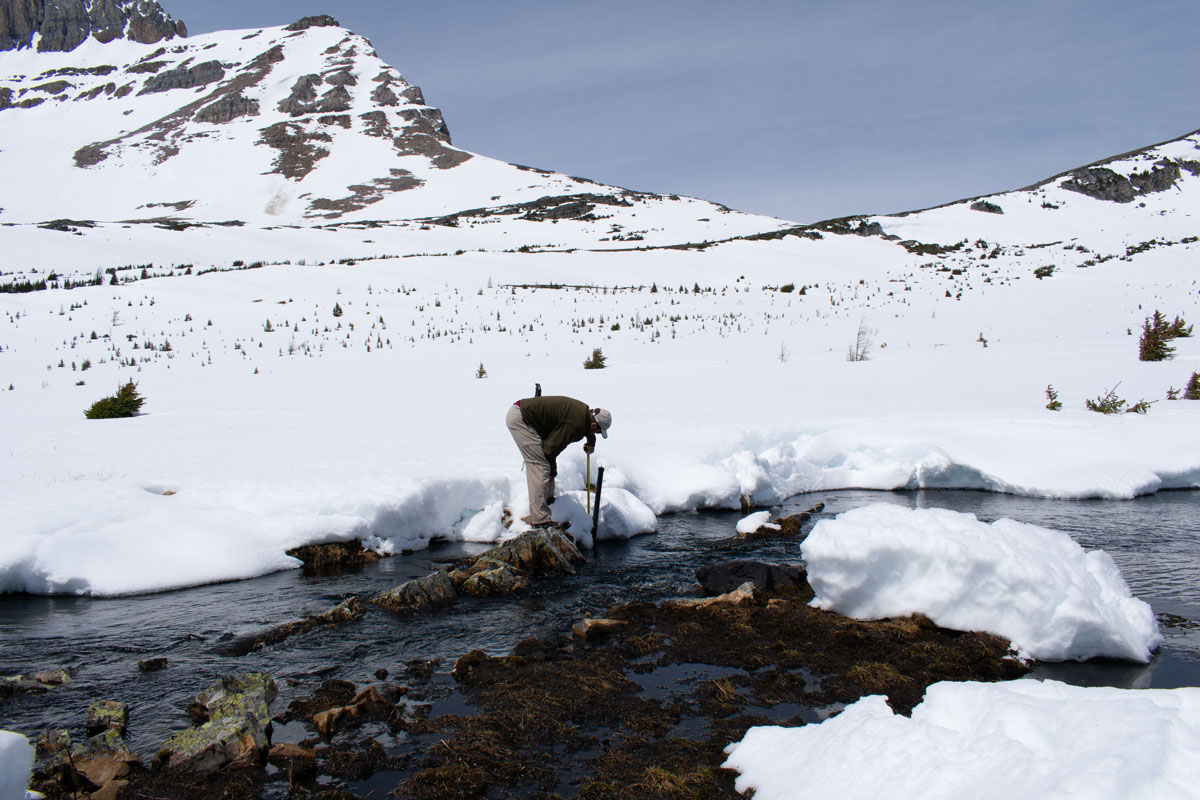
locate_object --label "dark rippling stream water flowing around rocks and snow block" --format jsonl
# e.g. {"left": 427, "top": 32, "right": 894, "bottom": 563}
{"left": 0, "top": 491, "right": 1200, "bottom": 754}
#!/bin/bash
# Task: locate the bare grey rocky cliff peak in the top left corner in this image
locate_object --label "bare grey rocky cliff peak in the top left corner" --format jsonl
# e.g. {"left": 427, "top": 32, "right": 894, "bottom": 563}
{"left": 0, "top": 0, "right": 187, "bottom": 53}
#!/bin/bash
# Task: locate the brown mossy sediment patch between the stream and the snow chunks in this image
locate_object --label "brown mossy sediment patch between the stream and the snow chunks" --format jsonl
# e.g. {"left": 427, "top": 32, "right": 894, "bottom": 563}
{"left": 401, "top": 578, "right": 1026, "bottom": 800}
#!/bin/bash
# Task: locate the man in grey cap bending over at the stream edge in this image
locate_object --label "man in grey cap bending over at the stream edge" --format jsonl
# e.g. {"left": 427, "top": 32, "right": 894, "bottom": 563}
{"left": 505, "top": 396, "right": 612, "bottom": 528}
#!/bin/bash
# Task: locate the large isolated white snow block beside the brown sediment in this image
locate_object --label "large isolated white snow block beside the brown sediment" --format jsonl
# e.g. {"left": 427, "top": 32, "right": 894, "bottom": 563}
{"left": 802, "top": 504, "right": 1163, "bottom": 662}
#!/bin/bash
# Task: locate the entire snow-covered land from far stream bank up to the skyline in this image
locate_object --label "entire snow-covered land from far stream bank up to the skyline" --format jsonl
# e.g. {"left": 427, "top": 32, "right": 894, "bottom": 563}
{"left": 0, "top": 0, "right": 1200, "bottom": 594}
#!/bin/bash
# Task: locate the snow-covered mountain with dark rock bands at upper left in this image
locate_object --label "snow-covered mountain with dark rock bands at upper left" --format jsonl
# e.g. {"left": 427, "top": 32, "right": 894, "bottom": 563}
{"left": 0, "top": 0, "right": 778, "bottom": 247}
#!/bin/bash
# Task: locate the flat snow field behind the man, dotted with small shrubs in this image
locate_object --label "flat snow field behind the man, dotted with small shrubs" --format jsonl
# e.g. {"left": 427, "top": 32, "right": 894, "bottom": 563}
{"left": 0, "top": 230, "right": 1200, "bottom": 595}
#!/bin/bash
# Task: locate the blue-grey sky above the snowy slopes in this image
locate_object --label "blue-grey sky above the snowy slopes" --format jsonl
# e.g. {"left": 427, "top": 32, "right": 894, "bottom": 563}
{"left": 160, "top": 0, "right": 1200, "bottom": 222}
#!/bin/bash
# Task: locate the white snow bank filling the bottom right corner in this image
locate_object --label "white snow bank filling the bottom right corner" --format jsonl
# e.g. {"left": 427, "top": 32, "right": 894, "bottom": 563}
{"left": 724, "top": 680, "right": 1200, "bottom": 800}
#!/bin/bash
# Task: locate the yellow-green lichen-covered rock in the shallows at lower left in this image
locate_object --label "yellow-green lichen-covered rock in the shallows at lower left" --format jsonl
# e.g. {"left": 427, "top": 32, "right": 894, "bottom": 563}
{"left": 158, "top": 673, "right": 277, "bottom": 772}
